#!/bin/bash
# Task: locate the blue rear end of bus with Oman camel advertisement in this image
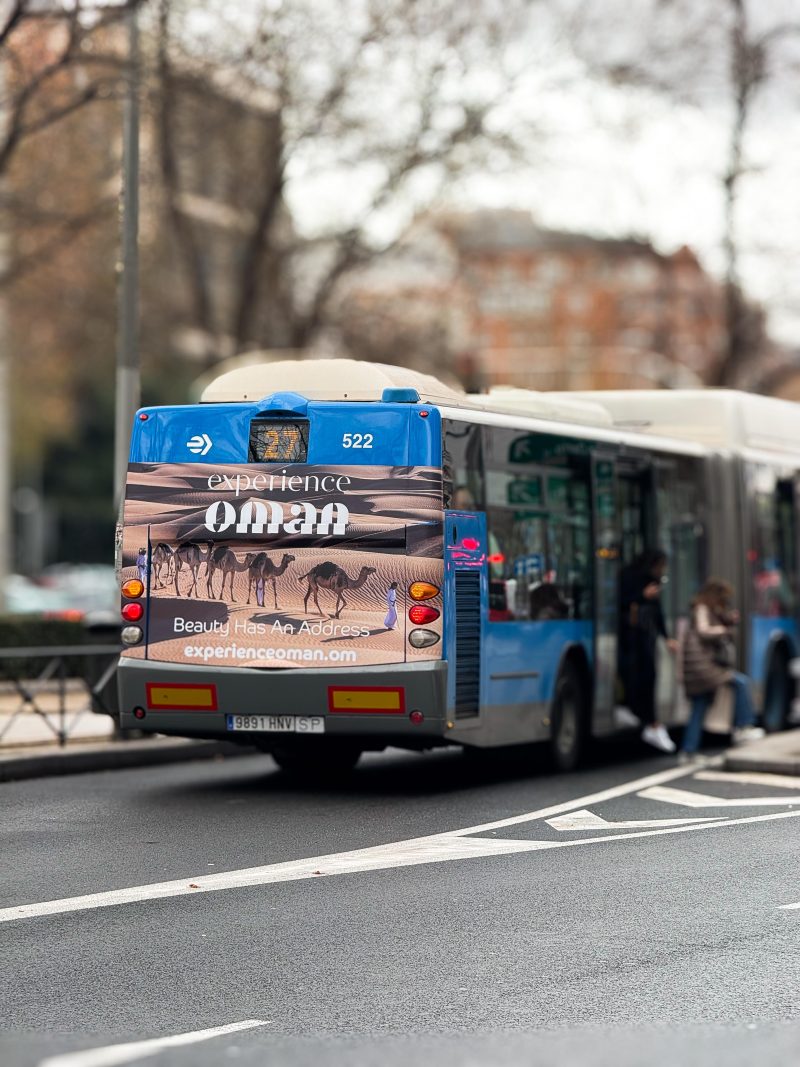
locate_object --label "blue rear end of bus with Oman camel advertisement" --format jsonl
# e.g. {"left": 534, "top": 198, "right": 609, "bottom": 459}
{"left": 117, "top": 361, "right": 446, "bottom": 758}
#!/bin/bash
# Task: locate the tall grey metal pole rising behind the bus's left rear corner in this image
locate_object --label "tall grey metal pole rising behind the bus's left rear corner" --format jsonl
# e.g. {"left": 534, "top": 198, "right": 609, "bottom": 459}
{"left": 114, "top": 3, "right": 141, "bottom": 507}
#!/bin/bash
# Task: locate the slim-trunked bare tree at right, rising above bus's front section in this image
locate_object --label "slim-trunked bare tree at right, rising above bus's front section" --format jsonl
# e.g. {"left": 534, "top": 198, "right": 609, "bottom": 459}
{"left": 555, "top": 0, "right": 800, "bottom": 385}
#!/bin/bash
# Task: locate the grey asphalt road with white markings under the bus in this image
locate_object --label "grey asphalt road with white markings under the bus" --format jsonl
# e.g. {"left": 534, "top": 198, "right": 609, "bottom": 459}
{"left": 0, "top": 749, "right": 800, "bottom": 1067}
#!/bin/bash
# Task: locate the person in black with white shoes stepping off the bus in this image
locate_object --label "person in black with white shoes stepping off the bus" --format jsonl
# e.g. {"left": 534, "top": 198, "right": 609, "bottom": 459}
{"left": 619, "top": 548, "right": 677, "bottom": 752}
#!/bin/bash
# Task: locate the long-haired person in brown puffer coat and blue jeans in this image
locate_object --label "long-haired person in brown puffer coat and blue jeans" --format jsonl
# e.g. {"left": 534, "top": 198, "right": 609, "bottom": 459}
{"left": 681, "top": 578, "right": 764, "bottom": 762}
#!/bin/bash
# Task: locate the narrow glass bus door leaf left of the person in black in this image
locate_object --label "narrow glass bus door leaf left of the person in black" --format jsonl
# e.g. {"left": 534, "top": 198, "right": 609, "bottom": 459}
{"left": 592, "top": 455, "right": 620, "bottom": 734}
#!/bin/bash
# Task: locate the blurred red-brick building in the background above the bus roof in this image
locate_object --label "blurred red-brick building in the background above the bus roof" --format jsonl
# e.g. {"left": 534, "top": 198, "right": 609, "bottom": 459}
{"left": 336, "top": 210, "right": 785, "bottom": 389}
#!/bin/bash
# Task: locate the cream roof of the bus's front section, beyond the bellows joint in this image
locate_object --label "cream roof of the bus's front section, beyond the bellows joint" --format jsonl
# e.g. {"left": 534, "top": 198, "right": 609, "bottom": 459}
{"left": 554, "top": 388, "right": 800, "bottom": 453}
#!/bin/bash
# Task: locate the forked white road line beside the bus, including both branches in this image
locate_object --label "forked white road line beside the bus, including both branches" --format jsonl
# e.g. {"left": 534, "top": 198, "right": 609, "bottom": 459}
{"left": 0, "top": 767, "right": 800, "bottom": 922}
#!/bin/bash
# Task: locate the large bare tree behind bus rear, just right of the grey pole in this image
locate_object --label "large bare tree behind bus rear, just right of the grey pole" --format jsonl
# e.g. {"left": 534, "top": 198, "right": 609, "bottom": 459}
{"left": 151, "top": 0, "right": 533, "bottom": 362}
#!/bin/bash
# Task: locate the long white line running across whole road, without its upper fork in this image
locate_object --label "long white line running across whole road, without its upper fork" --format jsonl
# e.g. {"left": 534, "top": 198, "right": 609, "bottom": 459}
{"left": 0, "top": 811, "right": 800, "bottom": 923}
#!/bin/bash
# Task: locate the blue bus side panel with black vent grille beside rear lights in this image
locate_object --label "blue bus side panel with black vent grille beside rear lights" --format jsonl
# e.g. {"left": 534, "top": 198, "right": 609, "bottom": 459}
{"left": 445, "top": 511, "right": 489, "bottom": 726}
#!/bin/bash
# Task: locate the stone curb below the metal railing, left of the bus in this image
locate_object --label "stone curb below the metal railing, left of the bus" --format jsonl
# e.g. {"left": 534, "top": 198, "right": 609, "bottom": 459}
{"left": 0, "top": 737, "right": 255, "bottom": 782}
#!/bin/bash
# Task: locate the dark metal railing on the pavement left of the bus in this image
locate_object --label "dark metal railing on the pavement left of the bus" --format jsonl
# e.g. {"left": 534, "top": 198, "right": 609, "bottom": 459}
{"left": 0, "top": 644, "right": 122, "bottom": 747}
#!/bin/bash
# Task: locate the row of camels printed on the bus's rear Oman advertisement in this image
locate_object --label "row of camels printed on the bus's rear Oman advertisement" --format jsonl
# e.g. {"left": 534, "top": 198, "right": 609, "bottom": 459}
{"left": 150, "top": 541, "right": 375, "bottom": 619}
